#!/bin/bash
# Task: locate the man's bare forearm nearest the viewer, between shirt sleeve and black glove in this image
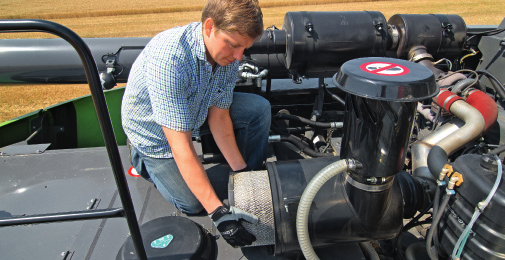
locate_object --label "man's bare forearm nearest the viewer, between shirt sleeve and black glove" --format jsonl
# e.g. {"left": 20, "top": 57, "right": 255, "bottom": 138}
{"left": 163, "top": 127, "right": 223, "bottom": 213}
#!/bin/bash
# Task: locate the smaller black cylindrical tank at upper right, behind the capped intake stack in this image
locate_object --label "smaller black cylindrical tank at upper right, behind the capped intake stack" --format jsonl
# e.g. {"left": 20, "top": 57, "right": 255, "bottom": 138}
{"left": 388, "top": 14, "right": 466, "bottom": 59}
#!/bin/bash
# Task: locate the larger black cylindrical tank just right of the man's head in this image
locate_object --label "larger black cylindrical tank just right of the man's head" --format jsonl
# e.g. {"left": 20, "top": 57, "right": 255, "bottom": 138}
{"left": 283, "top": 11, "right": 387, "bottom": 77}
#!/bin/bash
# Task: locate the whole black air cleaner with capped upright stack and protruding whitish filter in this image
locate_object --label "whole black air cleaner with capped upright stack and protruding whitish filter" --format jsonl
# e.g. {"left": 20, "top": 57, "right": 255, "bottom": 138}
{"left": 229, "top": 58, "right": 438, "bottom": 254}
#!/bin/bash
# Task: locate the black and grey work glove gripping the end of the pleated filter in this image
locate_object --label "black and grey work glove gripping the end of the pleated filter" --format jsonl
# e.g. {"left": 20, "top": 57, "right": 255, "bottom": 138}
{"left": 209, "top": 206, "right": 259, "bottom": 247}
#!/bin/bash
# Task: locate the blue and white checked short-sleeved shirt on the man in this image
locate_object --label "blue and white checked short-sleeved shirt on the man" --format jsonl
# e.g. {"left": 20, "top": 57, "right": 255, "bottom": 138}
{"left": 121, "top": 23, "right": 239, "bottom": 158}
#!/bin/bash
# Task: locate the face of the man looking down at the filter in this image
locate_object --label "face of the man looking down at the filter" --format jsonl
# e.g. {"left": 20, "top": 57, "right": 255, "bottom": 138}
{"left": 203, "top": 18, "right": 254, "bottom": 66}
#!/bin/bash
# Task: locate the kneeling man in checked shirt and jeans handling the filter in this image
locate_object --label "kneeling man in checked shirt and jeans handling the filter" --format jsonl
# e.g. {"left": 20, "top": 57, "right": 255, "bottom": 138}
{"left": 121, "top": 0, "right": 270, "bottom": 246}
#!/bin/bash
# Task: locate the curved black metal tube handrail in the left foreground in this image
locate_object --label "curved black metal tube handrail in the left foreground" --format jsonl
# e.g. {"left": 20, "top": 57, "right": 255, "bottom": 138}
{"left": 0, "top": 19, "right": 147, "bottom": 260}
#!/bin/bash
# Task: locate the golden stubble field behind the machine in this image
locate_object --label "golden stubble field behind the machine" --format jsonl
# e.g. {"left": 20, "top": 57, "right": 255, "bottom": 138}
{"left": 0, "top": 0, "right": 505, "bottom": 122}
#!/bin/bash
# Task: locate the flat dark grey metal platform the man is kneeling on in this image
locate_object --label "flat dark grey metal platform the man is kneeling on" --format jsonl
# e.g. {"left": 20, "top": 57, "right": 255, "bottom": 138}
{"left": 0, "top": 146, "right": 359, "bottom": 260}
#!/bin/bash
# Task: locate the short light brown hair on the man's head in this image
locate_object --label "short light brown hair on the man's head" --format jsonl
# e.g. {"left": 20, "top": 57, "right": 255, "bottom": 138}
{"left": 202, "top": 0, "right": 263, "bottom": 39}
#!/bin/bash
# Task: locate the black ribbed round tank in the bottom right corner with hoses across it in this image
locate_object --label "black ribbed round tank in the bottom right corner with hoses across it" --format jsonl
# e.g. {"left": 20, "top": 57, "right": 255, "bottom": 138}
{"left": 438, "top": 154, "right": 505, "bottom": 260}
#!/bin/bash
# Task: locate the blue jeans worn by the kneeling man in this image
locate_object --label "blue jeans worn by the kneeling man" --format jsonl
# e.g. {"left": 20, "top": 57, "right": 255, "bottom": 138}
{"left": 131, "top": 93, "right": 271, "bottom": 214}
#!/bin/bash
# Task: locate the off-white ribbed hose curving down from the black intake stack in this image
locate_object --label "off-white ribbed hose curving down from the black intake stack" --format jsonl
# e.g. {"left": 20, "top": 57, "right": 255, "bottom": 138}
{"left": 296, "top": 160, "right": 355, "bottom": 260}
